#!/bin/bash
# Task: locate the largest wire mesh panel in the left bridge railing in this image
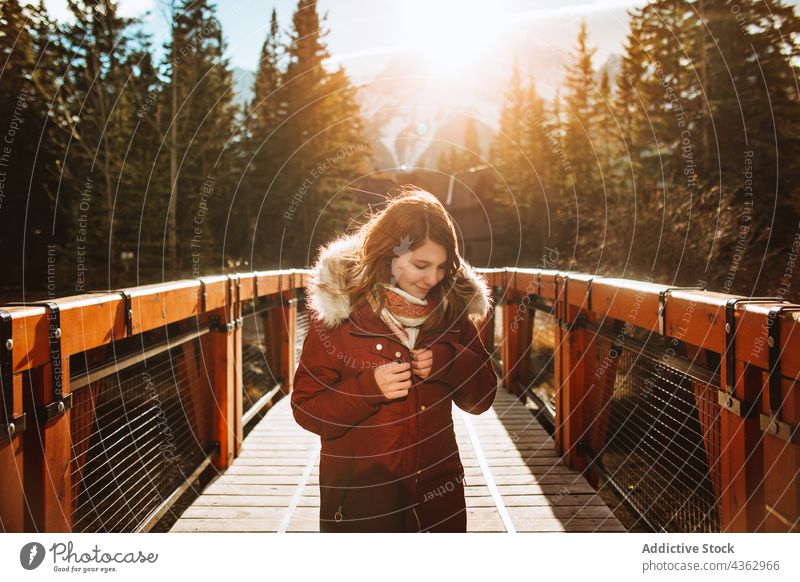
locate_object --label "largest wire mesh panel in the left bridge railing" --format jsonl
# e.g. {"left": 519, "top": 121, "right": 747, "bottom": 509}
{"left": 71, "top": 338, "right": 212, "bottom": 532}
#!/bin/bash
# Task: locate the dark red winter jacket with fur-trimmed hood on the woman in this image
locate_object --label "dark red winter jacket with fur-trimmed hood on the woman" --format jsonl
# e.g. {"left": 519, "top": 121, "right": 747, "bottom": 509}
{"left": 291, "top": 235, "right": 497, "bottom": 532}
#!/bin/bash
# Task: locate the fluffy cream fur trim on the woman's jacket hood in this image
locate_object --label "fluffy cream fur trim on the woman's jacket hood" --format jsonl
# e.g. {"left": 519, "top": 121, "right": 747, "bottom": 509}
{"left": 306, "top": 234, "right": 491, "bottom": 328}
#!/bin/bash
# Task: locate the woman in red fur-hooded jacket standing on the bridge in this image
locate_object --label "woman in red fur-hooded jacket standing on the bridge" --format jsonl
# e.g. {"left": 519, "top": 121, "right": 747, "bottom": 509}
{"left": 291, "top": 190, "right": 497, "bottom": 532}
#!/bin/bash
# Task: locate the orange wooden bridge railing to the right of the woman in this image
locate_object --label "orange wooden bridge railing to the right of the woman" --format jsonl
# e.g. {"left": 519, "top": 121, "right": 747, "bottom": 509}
{"left": 494, "top": 269, "right": 800, "bottom": 532}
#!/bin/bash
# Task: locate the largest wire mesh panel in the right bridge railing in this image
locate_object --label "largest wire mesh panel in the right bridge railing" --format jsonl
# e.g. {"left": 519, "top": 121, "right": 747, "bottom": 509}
{"left": 587, "top": 336, "right": 721, "bottom": 532}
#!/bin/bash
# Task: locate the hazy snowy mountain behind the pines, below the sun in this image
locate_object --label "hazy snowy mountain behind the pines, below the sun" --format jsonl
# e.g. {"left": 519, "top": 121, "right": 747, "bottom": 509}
{"left": 233, "top": 50, "right": 619, "bottom": 171}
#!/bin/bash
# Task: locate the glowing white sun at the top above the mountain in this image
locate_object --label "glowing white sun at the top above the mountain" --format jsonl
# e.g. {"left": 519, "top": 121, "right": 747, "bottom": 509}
{"left": 399, "top": 0, "right": 509, "bottom": 75}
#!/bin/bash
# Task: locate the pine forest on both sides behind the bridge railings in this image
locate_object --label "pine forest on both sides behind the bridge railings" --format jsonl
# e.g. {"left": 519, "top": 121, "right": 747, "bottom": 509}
{"left": 0, "top": 0, "right": 800, "bottom": 300}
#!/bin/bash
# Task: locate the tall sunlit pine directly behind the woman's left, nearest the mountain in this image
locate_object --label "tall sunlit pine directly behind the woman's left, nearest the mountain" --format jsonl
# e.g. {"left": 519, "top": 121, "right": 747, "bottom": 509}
{"left": 268, "top": 0, "right": 369, "bottom": 266}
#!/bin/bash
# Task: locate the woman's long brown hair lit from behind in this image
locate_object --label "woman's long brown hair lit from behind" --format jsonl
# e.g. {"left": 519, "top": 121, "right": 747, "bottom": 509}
{"left": 347, "top": 186, "right": 474, "bottom": 332}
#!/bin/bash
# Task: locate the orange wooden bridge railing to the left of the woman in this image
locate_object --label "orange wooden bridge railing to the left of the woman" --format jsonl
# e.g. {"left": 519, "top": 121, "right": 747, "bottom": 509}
{"left": 0, "top": 271, "right": 305, "bottom": 532}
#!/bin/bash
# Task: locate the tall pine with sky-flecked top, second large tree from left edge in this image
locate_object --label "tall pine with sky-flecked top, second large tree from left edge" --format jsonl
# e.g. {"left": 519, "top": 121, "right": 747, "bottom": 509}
{"left": 43, "top": 0, "right": 151, "bottom": 290}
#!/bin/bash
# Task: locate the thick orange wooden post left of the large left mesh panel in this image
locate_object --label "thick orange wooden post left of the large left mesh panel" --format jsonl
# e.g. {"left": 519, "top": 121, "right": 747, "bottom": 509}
{"left": 23, "top": 356, "right": 72, "bottom": 533}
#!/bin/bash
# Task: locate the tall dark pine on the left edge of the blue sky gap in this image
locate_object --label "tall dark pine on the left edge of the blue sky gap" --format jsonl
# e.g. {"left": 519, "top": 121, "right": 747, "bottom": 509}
{"left": 161, "top": 0, "right": 236, "bottom": 276}
